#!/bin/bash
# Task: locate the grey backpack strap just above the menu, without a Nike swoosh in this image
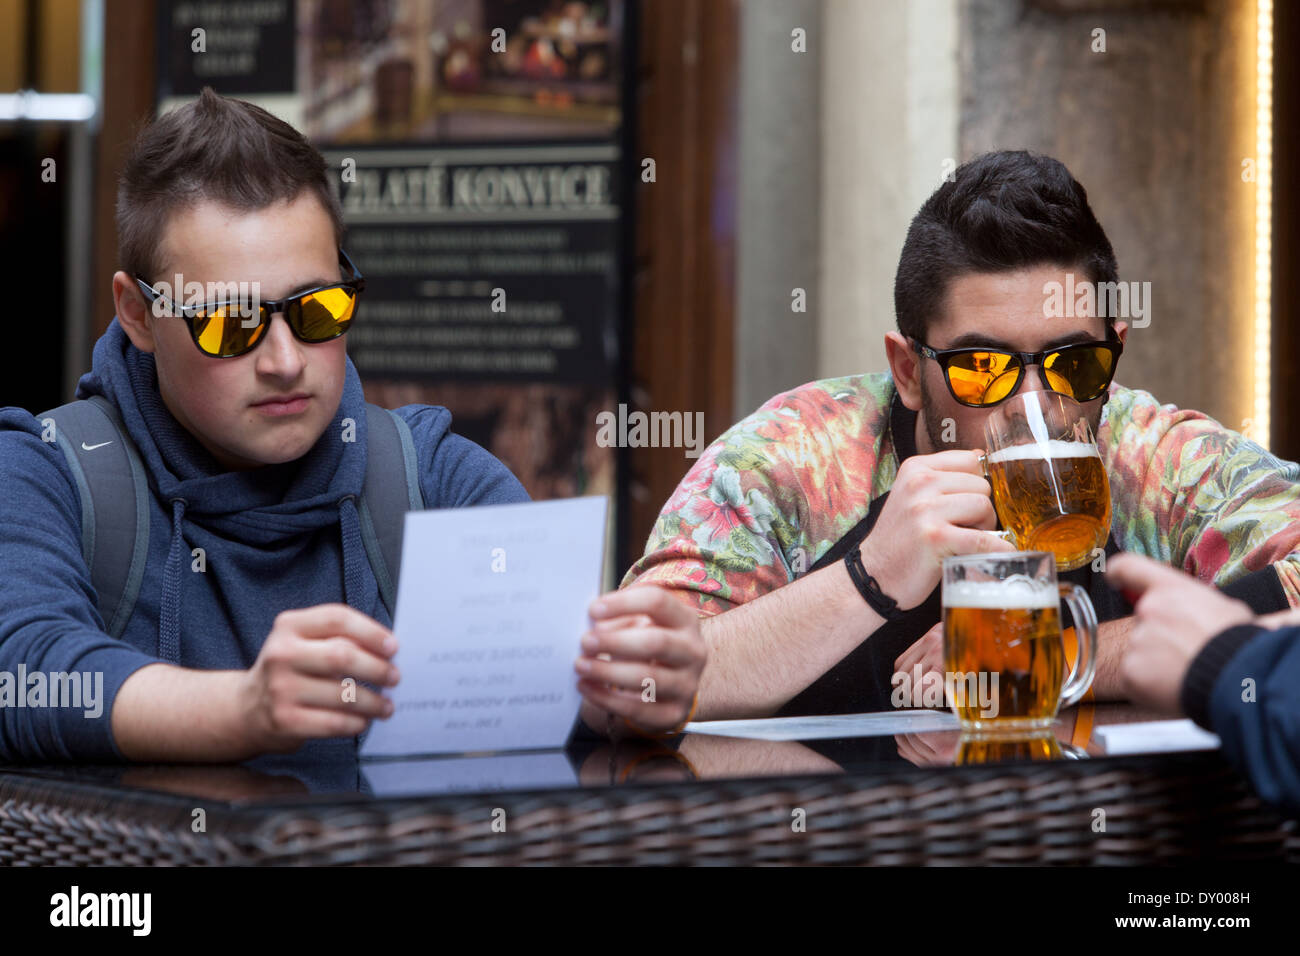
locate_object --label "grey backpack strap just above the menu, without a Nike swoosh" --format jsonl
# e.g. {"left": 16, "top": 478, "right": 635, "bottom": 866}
{"left": 358, "top": 402, "right": 424, "bottom": 618}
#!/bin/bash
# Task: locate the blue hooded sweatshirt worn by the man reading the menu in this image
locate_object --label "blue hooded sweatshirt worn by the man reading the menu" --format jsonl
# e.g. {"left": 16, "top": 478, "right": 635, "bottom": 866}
{"left": 0, "top": 317, "right": 528, "bottom": 762}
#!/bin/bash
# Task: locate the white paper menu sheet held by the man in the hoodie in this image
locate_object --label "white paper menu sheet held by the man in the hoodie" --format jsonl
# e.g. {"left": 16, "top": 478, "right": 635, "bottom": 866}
{"left": 361, "top": 497, "right": 606, "bottom": 757}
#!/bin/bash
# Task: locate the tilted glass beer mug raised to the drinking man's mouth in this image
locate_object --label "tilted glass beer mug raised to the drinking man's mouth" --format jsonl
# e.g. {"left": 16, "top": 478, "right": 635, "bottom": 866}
{"left": 982, "top": 392, "right": 1110, "bottom": 571}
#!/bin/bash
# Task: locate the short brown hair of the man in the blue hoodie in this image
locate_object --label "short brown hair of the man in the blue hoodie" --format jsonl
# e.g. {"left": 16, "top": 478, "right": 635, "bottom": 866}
{"left": 117, "top": 86, "right": 343, "bottom": 282}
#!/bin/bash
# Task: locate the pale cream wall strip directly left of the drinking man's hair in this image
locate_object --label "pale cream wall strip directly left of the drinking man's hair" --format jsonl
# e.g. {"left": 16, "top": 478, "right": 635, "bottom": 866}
{"left": 816, "top": 0, "right": 958, "bottom": 377}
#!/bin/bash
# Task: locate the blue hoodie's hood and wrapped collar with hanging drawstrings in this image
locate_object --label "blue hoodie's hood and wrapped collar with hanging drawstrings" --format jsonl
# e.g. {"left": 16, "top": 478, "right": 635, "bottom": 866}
{"left": 77, "top": 316, "right": 368, "bottom": 663}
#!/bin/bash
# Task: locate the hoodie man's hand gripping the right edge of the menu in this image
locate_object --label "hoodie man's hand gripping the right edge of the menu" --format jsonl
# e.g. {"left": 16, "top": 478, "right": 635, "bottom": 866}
{"left": 573, "top": 584, "right": 707, "bottom": 734}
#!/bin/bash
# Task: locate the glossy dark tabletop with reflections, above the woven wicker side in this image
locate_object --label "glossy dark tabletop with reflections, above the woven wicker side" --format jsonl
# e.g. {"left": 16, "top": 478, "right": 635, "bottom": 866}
{"left": 0, "top": 702, "right": 1216, "bottom": 804}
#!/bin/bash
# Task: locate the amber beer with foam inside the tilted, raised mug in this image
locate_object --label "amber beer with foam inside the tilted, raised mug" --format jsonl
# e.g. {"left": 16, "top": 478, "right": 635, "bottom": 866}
{"left": 987, "top": 441, "right": 1110, "bottom": 571}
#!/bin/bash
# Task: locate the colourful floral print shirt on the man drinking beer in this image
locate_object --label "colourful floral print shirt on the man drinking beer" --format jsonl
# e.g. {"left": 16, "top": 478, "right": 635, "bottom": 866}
{"left": 623, "top": 373, "right": 1300, "bottom": 615}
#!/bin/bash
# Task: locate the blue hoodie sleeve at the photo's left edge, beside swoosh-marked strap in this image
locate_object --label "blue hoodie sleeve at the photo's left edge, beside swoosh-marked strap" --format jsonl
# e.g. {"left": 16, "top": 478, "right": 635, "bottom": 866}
{"left": 0, "top": 408, "right": 159, "bottom": 762}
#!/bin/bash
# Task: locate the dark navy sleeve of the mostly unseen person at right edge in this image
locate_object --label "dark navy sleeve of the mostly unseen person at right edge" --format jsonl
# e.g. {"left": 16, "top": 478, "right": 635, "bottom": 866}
{"left": 1182, "top": 624, "right": 1300, "bottom": 816}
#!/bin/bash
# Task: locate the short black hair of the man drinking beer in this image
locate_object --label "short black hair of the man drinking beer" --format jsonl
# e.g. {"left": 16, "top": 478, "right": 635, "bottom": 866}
{"left": 894, "top": 150, "right": 1118, "bottom": 339}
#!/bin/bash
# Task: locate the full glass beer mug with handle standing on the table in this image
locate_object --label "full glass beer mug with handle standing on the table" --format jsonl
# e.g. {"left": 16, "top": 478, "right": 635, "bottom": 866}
{"left": 943, "top": 551, "right": 1097, "bottom": 732}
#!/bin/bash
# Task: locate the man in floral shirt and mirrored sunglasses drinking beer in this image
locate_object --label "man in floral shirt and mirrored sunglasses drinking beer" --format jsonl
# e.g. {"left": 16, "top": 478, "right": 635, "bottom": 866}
{"left": 623, "top": 152, "right": 1300, "bottom": 718}
